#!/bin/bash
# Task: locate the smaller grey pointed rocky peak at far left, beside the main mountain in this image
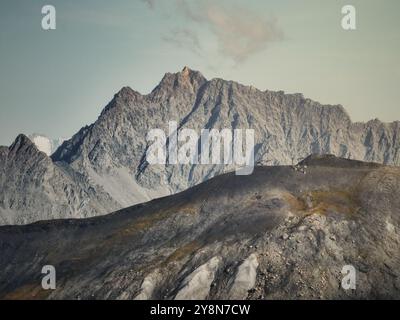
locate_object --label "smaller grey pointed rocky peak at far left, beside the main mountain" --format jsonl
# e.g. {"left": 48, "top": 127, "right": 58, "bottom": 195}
{"left": 0, "top": 135, "right": 116, "bottom": 224}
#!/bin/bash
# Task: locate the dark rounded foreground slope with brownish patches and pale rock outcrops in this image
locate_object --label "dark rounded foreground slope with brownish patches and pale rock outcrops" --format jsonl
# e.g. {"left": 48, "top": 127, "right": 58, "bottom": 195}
{"left": 0, "top": 156, "right": 400, "bottom": 299}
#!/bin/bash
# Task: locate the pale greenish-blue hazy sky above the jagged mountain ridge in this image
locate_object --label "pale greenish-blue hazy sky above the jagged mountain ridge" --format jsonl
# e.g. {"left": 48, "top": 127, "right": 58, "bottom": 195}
{"left": 0, "top": 0, "right": 400, "bottom": 145}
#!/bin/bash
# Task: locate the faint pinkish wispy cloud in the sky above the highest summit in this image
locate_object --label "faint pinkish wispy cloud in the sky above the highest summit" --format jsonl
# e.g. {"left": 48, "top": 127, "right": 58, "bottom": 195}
{"left": 142, "top": 0, "right": 284, "bottom": 63}
